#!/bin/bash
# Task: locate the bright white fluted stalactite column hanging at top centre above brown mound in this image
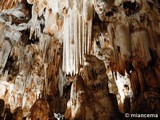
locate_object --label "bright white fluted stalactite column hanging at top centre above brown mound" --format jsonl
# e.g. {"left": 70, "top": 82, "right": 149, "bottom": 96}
{"left": 62, "top": 0, "right": 93, "bottom": 74}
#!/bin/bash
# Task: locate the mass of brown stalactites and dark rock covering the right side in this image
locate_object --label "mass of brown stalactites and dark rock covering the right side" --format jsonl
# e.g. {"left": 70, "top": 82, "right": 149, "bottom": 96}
{"left": 93, "top": 0, "right": 160, "bottom": 113}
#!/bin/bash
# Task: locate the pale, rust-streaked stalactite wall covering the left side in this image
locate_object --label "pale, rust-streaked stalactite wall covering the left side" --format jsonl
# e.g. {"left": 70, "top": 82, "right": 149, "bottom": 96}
{"left": 0, "top": 0, "right": 64, "bottom": 116}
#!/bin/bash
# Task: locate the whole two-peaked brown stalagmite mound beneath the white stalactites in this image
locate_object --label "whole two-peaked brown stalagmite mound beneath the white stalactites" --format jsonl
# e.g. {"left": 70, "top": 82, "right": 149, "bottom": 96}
{"left": 65, "top": 55, "right": 118, "bottom": 120}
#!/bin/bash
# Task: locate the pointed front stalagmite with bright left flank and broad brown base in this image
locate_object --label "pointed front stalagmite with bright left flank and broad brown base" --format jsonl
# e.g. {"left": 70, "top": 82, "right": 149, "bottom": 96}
{"left": 65, "top": 76, "right": 118, "bottom": 120}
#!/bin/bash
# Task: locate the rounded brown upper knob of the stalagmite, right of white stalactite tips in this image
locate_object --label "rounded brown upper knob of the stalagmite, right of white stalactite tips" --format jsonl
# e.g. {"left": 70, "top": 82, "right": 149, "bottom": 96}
{"left": 82, "top": 55, "right": 109, "bottom": 96}
